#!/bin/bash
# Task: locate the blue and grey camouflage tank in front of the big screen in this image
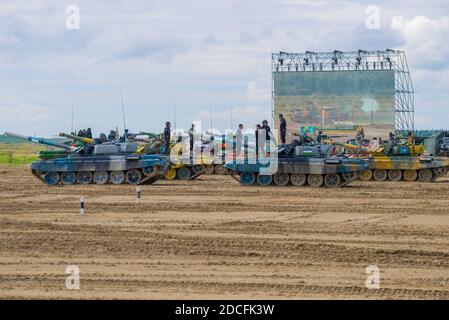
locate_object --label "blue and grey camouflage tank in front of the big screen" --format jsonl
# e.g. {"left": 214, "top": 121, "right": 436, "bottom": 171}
{"left": 225, "top": 140, "right": 368, "bottom": 188}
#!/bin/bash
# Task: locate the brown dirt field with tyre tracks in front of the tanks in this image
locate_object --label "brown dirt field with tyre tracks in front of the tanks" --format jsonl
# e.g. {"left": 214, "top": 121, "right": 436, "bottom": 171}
{"left": 0, "top": 167, "right": 449, "bottom": 299}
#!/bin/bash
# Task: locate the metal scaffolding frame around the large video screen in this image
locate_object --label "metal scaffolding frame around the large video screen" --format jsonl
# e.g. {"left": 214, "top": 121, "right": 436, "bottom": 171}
{"left": 271, "top": 49, "right": 415, "bottom": 131}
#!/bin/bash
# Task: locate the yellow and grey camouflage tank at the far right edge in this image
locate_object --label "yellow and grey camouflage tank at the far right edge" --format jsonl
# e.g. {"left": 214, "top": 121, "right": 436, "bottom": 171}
{"left": 332, "top": 142, "right": 449, "bottom": 182}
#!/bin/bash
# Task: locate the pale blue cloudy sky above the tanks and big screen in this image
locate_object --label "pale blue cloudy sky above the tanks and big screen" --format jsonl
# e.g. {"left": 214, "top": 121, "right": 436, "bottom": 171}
{"left": 0, "top": 0, "right": 449, "bottom": 136}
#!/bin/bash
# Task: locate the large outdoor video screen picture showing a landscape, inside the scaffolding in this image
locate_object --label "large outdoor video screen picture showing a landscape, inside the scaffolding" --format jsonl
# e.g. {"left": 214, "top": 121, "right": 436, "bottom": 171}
{"left": 273, "top": 70, "right": 395, "bottom": 140}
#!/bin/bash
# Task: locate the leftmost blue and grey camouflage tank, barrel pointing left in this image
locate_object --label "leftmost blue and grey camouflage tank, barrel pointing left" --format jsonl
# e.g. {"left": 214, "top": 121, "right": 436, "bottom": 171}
{"left": 8, "top": 135, "right": 169, "bottom": 186}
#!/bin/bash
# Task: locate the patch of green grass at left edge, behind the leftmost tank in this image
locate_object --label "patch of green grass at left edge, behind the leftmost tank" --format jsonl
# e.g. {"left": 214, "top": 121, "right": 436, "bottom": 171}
{"left": 0, "top": 143, "right": 48, "bottom": 166}
